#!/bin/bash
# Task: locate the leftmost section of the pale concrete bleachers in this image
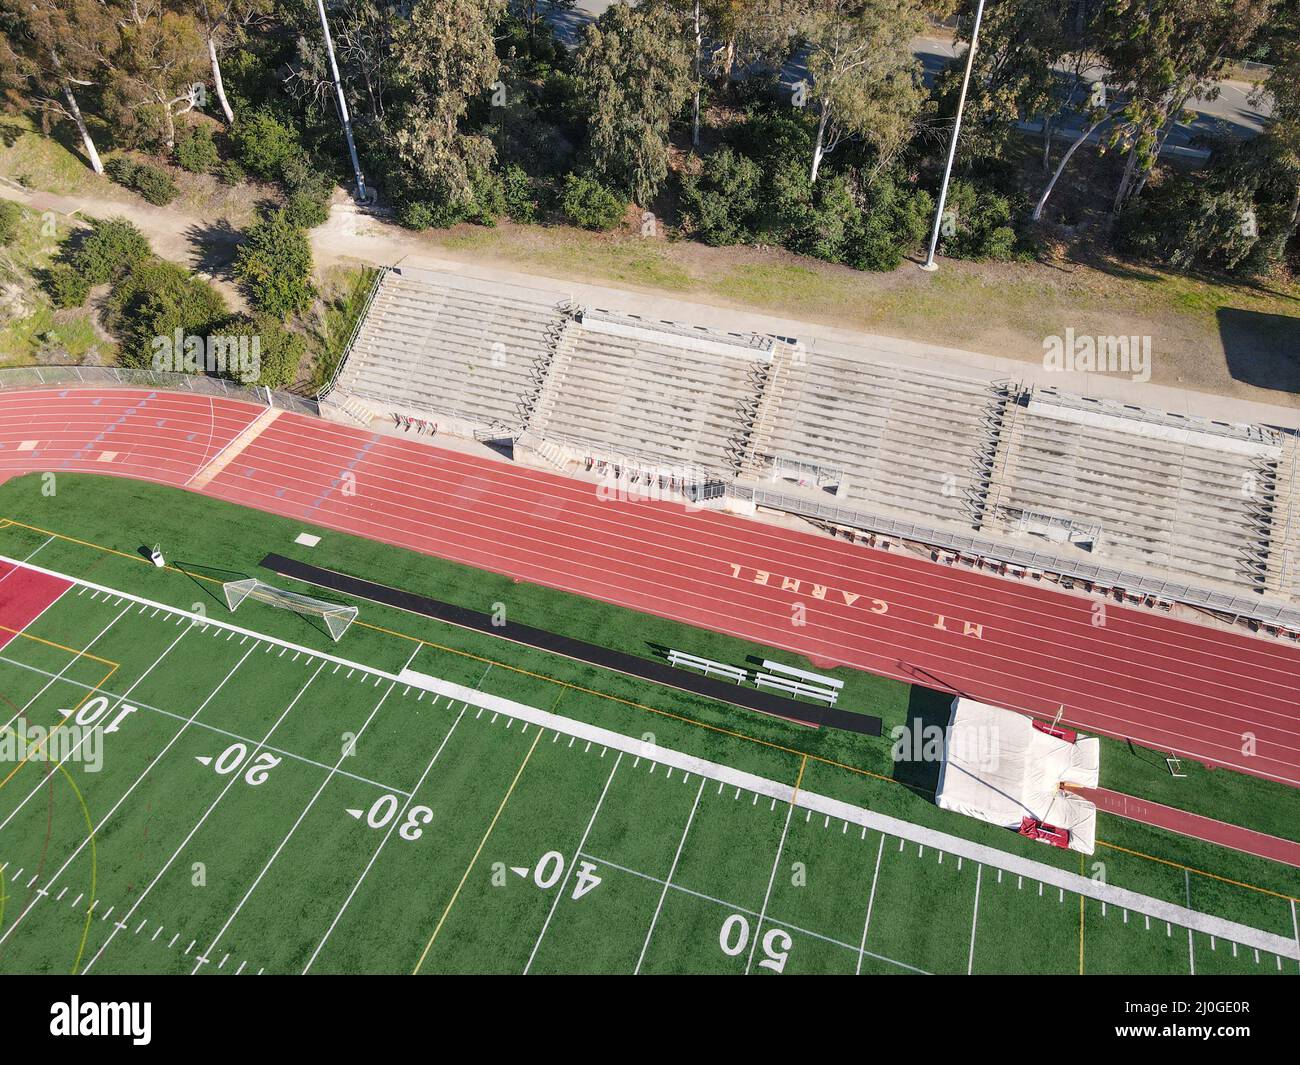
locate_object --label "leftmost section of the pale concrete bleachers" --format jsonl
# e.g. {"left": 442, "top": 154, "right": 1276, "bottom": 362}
{"left": 337, "top": 270, "right": 564, "bottom": 427}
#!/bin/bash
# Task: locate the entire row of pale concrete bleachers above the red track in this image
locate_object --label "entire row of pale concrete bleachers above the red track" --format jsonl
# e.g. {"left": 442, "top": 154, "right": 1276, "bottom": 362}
{"left": 322, "top": 269, "right": 1300, "bottom": 629}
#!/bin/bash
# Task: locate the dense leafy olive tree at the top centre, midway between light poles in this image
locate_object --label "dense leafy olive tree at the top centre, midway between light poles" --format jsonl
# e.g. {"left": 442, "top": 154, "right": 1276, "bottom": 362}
{"left": 573, "top": 3, "right": 693, "bottom": 207}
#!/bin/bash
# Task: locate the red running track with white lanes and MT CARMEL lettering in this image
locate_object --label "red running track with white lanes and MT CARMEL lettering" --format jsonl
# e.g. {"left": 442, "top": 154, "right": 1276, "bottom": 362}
{"left": 0, "top": 389, "right": 1300, "bottom": 785}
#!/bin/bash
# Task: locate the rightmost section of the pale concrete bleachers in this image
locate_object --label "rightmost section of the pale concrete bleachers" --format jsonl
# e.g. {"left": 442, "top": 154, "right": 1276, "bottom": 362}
{"left": 995, "top": 397, "right": 1281, "bottom": 586}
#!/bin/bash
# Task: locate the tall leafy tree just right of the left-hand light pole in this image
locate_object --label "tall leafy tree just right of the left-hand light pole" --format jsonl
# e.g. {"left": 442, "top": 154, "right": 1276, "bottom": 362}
{"left": 385, "top": 0, "right": 504, "bottom": 218}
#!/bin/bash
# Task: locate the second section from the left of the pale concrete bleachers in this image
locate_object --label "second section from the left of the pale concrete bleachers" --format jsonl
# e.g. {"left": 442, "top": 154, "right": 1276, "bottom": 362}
{"left": 529, "top": 312, "right": 770, "bottom": 475}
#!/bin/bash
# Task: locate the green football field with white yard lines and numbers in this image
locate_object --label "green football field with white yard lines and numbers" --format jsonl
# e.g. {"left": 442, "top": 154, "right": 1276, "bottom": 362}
{"left": 0, "top": 478, "right": 1297, "bottom": 975}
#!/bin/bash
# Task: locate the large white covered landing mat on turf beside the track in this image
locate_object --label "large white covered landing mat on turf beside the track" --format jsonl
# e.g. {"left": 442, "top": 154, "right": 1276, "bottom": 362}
{"left": 936, "top": 696, "right": 1100, "bottom": 854}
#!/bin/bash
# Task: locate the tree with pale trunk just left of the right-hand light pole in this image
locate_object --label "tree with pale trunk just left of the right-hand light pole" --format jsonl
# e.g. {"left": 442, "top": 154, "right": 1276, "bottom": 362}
{"left": 802, "top": 0, "right": 924, "bottom": 182}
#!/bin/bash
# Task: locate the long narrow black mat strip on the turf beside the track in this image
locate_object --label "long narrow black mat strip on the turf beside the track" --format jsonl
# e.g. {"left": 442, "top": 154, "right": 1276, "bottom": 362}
{"left": 261, "top": 554, "right": 880, "bottom": 736}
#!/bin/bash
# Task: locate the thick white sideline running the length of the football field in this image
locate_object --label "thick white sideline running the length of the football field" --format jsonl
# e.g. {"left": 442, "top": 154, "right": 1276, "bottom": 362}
{"left": 0, "top": 555, "right": 1300, "bottom": 961}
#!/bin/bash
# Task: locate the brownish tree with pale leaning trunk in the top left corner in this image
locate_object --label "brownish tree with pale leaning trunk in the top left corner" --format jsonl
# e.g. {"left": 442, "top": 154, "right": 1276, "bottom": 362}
{"left": 0, "top": 0, "right": 117, "bottom": 174}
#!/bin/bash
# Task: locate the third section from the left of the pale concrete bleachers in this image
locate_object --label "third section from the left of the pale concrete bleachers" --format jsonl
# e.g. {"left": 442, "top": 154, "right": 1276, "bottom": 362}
{"left": 768, "top": 352, "right": 1005, "bottom": 528}
